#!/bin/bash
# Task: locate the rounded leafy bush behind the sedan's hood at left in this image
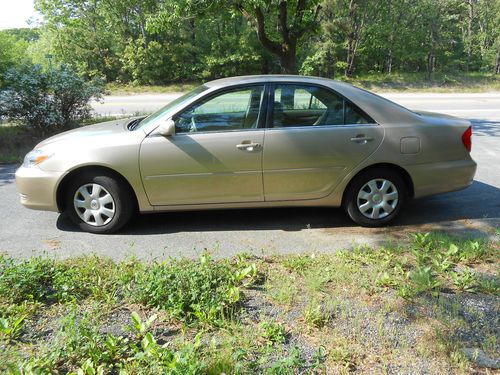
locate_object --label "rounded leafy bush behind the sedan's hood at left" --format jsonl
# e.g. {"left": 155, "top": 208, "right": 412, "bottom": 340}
{"left": 0, "top": 64, "right": 104, "bottom": 136}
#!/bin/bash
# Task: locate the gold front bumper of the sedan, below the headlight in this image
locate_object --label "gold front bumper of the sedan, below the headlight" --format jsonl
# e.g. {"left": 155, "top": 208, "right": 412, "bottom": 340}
{"left": 16, "top": 167, "right": 64, "bottom": 212}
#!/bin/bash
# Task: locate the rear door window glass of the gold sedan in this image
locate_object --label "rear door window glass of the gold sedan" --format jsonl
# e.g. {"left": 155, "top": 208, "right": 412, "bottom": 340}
{"left": 273, "top": 85, "right": 373, "bottom": 128}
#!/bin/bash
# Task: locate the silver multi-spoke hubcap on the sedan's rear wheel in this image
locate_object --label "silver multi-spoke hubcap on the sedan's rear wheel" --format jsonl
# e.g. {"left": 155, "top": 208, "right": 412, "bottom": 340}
{"left": 357, "top": 178, "right": 399, "bottom": 219}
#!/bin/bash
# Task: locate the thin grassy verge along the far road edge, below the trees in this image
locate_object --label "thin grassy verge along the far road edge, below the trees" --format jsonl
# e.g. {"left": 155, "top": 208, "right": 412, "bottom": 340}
{"left": 103, "top": 72, "right": 500, "bottom": 95}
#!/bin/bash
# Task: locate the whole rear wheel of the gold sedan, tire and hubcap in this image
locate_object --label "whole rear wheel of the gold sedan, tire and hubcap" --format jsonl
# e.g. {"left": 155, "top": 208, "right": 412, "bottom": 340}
{"left": 343, "top": 168, "right": 408, "bottom": 227}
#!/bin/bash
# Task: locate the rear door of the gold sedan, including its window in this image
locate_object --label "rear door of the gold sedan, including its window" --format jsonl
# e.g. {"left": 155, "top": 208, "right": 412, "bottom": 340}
{"left": 263, "top": 84, "right": 384, "bottom": 201}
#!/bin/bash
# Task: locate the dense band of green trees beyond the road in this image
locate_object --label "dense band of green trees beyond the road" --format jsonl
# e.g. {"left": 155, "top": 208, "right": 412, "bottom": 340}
{"left": 28, "top": 0, "right": 500, "bottom": 84}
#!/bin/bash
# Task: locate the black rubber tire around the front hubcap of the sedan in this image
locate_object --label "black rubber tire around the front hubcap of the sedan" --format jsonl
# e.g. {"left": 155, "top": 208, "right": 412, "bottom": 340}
{"left": 64, "top": 173, "right": 134, "bottom": 234}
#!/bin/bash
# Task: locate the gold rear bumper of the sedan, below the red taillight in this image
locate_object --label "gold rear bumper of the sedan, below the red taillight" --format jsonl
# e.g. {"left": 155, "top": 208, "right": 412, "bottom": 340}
{"left": 405, "top": 159, "right": 477, "bottom": 198}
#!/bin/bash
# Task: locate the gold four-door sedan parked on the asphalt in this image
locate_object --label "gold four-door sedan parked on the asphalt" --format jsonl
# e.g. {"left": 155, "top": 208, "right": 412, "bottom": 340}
{"left": 16, "top": 75, "right": 476, "bottom": 233}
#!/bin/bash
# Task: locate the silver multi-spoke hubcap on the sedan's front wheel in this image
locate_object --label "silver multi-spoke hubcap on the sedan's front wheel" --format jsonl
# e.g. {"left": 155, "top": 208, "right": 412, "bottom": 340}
{"left": 73, "top": 184, "right": 116, "bottom": 227}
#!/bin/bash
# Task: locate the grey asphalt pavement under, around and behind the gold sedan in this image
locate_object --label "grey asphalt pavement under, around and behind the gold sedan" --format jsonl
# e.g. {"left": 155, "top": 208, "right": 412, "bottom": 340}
{"left": 0, "top": 94, "right": 500, "bottom": 259}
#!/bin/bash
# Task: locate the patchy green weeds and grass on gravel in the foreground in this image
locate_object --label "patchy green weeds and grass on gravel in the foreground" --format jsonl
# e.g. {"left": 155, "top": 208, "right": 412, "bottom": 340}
{"left": 0, "top": 233, "right": 500, "bottom": 375}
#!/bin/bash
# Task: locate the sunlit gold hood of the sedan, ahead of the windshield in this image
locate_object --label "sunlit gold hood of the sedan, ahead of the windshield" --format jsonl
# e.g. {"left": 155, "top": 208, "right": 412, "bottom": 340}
{"left": 35, "top": 118, "right": 137, "bottom": 148}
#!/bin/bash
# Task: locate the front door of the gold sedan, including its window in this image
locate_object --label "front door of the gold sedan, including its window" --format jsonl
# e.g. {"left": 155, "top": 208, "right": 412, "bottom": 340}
{"left": 140, "top": 85, "right": 264, "bottom": 206}
